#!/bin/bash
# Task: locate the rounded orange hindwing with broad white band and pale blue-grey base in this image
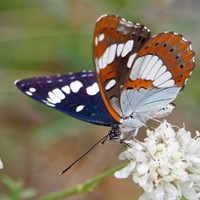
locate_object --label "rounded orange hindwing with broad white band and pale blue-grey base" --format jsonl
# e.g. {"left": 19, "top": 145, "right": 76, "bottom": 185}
{"left": 121, "top": 32, "right": 195, "bottom": 126}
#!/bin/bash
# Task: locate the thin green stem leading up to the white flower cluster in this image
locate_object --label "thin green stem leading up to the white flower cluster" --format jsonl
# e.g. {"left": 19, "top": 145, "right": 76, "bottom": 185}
{"left": 38, "top": 163, "right": 127, "bottom": 200}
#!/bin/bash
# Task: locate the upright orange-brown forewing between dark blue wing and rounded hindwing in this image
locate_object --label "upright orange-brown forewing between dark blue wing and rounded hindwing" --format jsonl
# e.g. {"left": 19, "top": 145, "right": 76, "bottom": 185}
{"left": 93, "top": 15, "right": 150, "bottom": 122}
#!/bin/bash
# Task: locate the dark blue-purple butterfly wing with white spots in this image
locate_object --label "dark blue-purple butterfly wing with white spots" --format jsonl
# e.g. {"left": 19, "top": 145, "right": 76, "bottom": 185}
{"left": 16, "top": 72, "right": 114, "bottom": 126}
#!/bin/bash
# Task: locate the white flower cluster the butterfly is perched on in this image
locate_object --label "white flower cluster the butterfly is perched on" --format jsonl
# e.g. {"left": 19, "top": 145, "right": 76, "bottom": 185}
{"left": 115, "top": 121, "right": 200, "bottom": 200}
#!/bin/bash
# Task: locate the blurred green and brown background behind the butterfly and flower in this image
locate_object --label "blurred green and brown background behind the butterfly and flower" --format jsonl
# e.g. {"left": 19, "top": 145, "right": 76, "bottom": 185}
{"left": 0, "top": 0, "right": 200, "bottom": 200}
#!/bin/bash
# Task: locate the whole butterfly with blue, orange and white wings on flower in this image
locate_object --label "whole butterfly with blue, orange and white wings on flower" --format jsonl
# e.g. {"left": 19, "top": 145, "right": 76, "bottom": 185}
{"left": 15, "top": 15, "right": 195, "bottom": 139}
